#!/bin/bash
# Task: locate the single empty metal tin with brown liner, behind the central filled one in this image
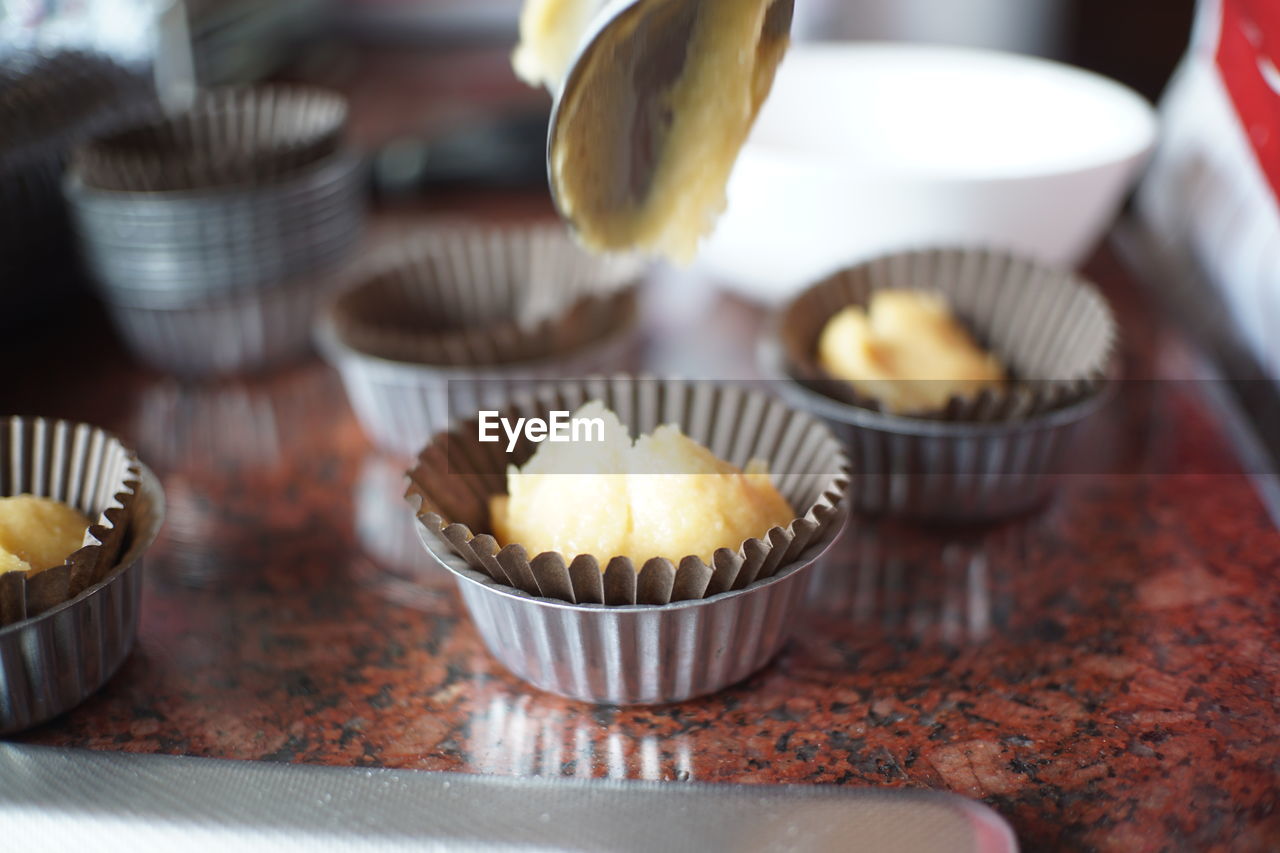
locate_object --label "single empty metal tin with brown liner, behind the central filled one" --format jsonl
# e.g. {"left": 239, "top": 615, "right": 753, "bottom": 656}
{"left": 316, "top": 225, "right": 641, "bottom": 456}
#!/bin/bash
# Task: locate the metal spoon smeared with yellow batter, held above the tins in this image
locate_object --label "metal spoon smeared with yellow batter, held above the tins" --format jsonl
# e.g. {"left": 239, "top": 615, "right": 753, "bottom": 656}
{"left": 547, "top": 0, "right": 794, "bottom": 242}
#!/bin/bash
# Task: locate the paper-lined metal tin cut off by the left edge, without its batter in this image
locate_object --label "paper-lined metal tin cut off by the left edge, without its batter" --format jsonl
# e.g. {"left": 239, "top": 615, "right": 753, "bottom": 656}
{"left": 0, "top": 418, "right": 164, "bottom": 734}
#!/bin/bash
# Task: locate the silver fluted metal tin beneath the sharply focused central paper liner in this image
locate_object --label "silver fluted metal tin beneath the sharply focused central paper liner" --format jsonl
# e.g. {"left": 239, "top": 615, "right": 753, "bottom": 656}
{"left": 417, "top": 510, "right": 847, "bottom": 704}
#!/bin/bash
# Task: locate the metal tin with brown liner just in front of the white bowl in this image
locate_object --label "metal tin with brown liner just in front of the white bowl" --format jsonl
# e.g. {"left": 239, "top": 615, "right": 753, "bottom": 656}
{"left": 759, "top": 250, "right": 1116, "bottom": 521}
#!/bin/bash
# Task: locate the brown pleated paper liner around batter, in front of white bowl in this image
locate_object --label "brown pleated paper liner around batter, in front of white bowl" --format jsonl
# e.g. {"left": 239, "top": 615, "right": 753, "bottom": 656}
{"left": 776, "top": 248, "right": 1117, "bottom": 423}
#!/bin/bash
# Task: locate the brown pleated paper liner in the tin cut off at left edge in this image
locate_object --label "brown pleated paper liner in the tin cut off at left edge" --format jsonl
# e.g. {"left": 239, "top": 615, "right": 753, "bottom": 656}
{"left": 0, "top": 416, "right": 141, "bottom": 625}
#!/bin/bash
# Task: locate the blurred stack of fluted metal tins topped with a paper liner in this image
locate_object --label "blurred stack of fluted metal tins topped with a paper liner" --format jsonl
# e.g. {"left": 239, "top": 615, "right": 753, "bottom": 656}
{"left": 63, "top": 86, "right": 365, "bottom": 366}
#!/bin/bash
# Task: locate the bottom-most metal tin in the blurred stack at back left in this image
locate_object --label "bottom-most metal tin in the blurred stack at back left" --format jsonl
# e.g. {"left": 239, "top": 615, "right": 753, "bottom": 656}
{"left": 106, "top": 258, "right": 340, "bottom": 377}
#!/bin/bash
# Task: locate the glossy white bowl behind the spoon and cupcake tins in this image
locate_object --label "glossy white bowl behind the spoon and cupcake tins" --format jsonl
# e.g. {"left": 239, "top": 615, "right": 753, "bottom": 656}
{"left": 699, "top": 44, "right": 1156, "bottom": 302}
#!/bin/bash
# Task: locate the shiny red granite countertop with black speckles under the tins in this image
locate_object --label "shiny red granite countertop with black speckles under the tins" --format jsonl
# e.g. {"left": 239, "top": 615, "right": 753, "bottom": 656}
{"left": 3, "top": 220, "right": 1280, "bottom": 850}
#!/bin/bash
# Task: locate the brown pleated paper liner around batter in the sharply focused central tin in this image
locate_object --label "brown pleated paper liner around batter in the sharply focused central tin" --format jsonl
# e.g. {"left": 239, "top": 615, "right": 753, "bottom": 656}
{"left": 406, "top": 377, "right": 849, "bottom": 606}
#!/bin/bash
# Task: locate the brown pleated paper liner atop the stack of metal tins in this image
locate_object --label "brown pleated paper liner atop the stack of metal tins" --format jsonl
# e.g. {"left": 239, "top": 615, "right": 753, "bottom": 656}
{"left": 73, "top": 85, "right": 347, "bottom": 192}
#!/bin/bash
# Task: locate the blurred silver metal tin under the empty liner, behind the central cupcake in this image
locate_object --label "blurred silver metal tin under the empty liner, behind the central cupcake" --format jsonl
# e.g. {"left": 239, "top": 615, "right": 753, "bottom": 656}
{"left": 316, "top": 315, "right": 639, "bottom": 456}
